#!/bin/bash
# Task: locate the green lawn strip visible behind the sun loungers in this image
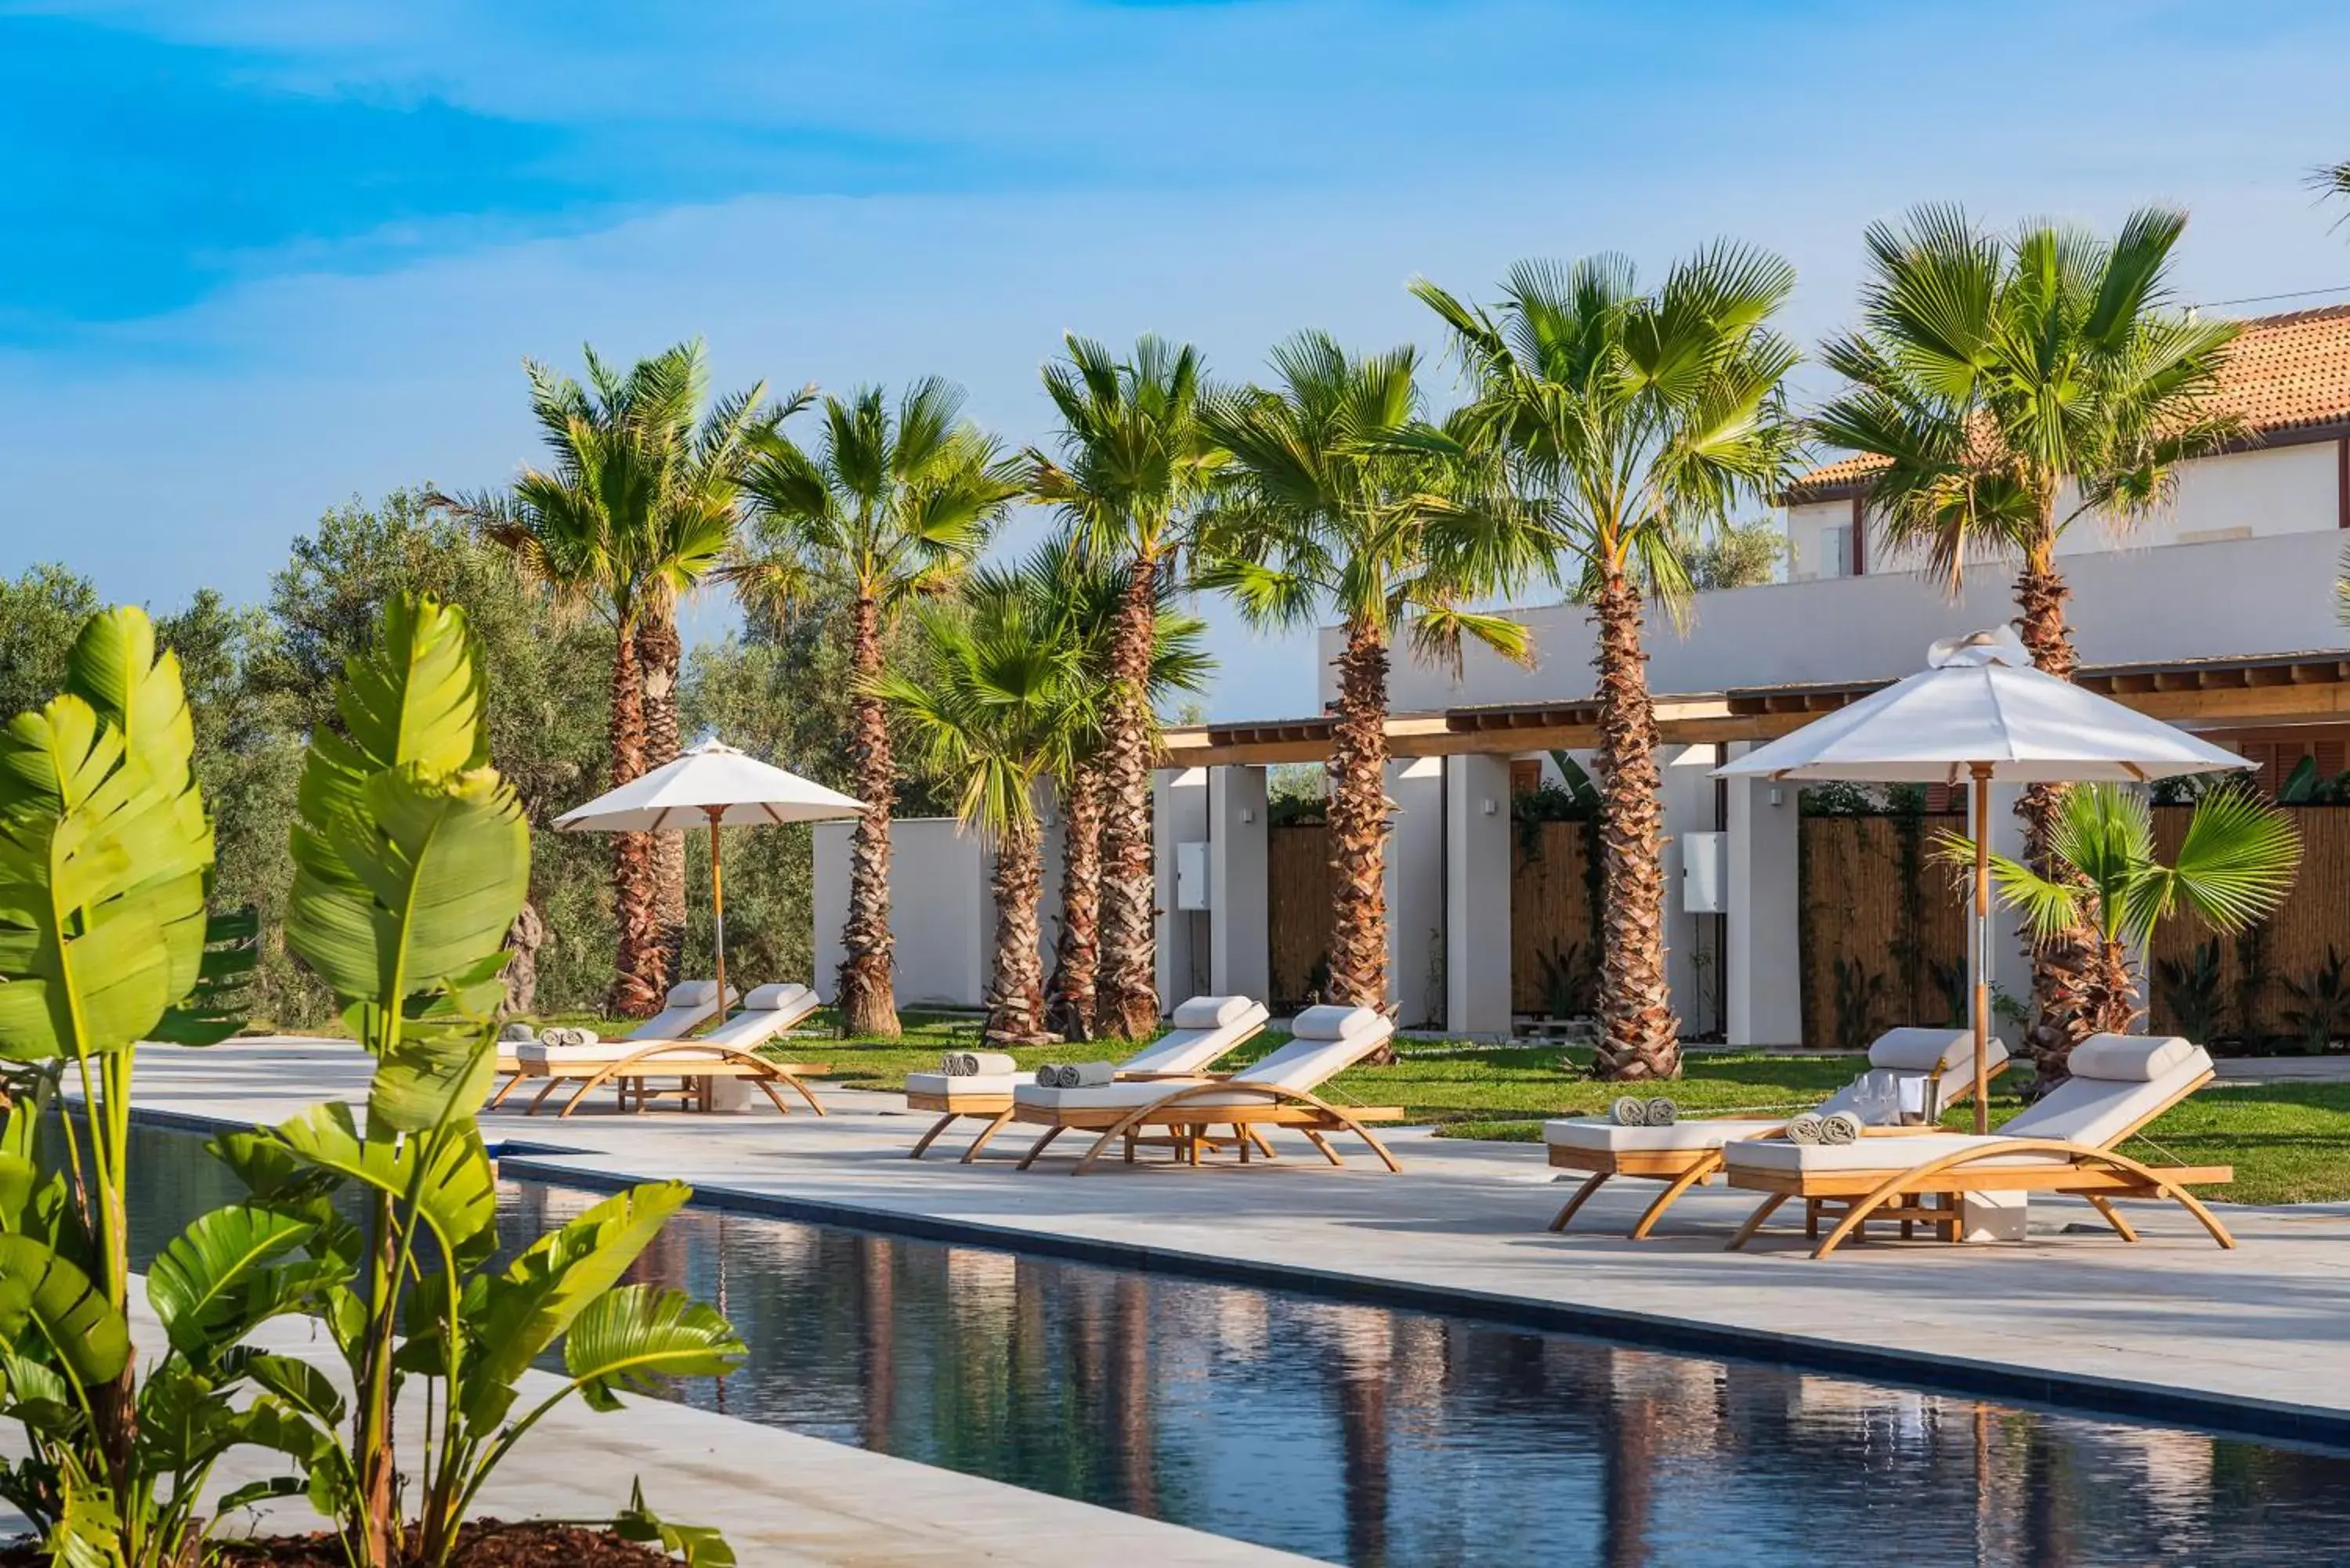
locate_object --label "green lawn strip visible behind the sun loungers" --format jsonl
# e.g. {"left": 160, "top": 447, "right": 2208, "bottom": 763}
{"left": 548, "top": 1011, "right": 2350, "bottom": 1204}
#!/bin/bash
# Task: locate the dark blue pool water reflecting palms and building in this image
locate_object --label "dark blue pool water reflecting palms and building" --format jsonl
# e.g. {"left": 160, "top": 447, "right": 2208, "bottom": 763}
{"left": 132, "top": 1129, "right": 2350, "bottom": 1568}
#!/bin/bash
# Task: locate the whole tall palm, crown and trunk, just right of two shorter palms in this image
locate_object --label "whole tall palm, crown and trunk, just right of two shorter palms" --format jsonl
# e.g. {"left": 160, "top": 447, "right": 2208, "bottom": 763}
{"left": 1027, "top": 336, "right": 1215, "bottom": 1039}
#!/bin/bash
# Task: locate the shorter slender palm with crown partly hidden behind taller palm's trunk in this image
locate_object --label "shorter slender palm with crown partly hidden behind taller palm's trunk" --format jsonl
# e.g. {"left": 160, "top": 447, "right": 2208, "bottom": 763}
{"left": 1020, "top": 538, "right": 1215, "bottom": 1039}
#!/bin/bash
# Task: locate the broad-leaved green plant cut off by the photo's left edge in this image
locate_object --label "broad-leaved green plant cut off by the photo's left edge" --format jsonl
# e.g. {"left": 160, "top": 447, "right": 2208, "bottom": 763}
{"left": 0, "top": 609, "right": 284, "bottom": 1566}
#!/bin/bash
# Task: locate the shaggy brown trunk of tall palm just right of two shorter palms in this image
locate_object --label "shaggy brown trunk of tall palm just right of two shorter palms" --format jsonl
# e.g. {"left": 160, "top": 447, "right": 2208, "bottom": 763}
{"left": 1095, "top": 557, "right": 1159, "bottom": 1039}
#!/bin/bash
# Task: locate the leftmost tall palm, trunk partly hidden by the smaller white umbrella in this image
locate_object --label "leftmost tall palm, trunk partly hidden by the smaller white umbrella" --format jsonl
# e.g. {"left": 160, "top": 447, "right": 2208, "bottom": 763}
{"left": 432, "top": 341, "right": 766, "bottom": 1018}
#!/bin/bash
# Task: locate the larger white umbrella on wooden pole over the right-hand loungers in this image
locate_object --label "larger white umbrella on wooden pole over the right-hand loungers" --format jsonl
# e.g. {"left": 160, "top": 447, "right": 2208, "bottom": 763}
{"left": 1713, "top": 625, "right": 2251, "bottom": 1133}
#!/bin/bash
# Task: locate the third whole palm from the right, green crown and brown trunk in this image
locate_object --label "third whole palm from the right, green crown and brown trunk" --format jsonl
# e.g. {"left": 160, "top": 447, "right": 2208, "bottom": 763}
{"left": 1198, "top": 331, "right": 1546, "bottom": 1029}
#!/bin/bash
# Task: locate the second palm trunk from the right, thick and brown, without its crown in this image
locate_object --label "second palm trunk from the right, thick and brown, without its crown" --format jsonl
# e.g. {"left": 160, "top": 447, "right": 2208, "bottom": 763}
{"left": 1591, "top": 573, "right": 1680, "bottom": 1082}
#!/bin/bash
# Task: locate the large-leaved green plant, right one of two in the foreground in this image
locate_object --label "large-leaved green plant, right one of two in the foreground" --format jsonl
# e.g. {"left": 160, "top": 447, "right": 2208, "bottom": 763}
{"left": 214, "top": 599, "right": 743, "bottom": 1568}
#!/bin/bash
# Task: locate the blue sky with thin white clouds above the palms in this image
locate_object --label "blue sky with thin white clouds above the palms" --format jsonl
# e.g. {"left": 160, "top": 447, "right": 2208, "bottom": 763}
{"left": 0, "top": 0, "right": 2350, "bottom": 717}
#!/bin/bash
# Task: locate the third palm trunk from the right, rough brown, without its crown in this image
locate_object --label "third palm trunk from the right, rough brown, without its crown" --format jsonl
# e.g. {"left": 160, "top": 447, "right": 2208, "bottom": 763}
{"left": 1330, "top": 625, "right": 1386, "bottom": 1024}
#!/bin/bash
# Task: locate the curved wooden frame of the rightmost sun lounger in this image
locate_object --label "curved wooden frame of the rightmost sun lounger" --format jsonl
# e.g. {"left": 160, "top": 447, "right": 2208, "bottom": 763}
{"left": 1730, "top": 1072, "right": 2235, "bottom": 1258}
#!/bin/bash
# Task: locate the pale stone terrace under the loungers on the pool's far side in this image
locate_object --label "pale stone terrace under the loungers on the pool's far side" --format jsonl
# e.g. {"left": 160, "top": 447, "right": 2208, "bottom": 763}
{"left": 119, "top": 1042, "right": 2350, "bottom": 1441}
